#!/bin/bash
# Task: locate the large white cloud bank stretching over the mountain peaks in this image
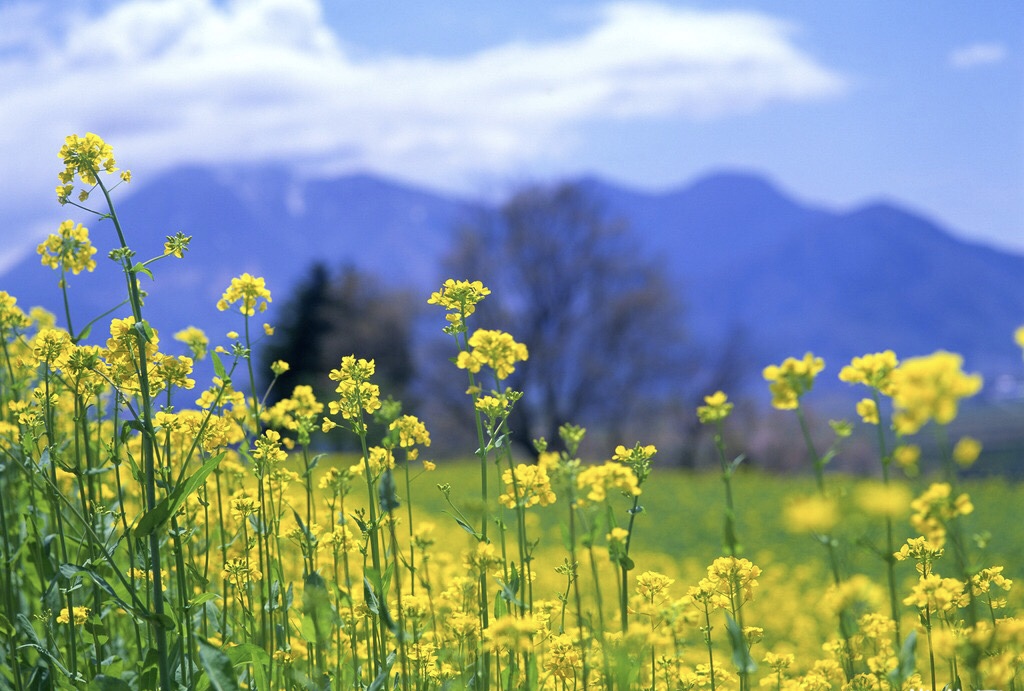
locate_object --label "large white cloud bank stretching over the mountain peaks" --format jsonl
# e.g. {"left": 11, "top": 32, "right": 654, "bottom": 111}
{"left": 0, "top": 0, "right": 845, "bottom": 243}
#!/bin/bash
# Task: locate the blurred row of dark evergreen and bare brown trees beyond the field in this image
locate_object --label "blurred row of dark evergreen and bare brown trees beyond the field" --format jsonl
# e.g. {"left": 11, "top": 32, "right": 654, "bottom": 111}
{"left": 262, "top": 183, "right": 739, "bottom": 463}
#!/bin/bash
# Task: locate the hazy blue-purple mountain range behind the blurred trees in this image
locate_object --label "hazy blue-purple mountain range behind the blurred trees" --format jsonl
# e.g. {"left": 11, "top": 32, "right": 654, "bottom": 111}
{"left": 0, "top": 166, "right": 1024, "bottom": 397}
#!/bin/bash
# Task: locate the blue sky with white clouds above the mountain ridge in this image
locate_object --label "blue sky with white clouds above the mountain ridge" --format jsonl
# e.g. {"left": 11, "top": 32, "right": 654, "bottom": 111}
{"left": 0, "top": 0, "right": 1024, "bottom": 264}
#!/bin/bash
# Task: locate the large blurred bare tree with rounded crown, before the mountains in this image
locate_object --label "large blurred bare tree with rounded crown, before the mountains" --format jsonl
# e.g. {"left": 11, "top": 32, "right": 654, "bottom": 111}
{"left": 451, "top": 183, "right": 684, "bottom": 454}
